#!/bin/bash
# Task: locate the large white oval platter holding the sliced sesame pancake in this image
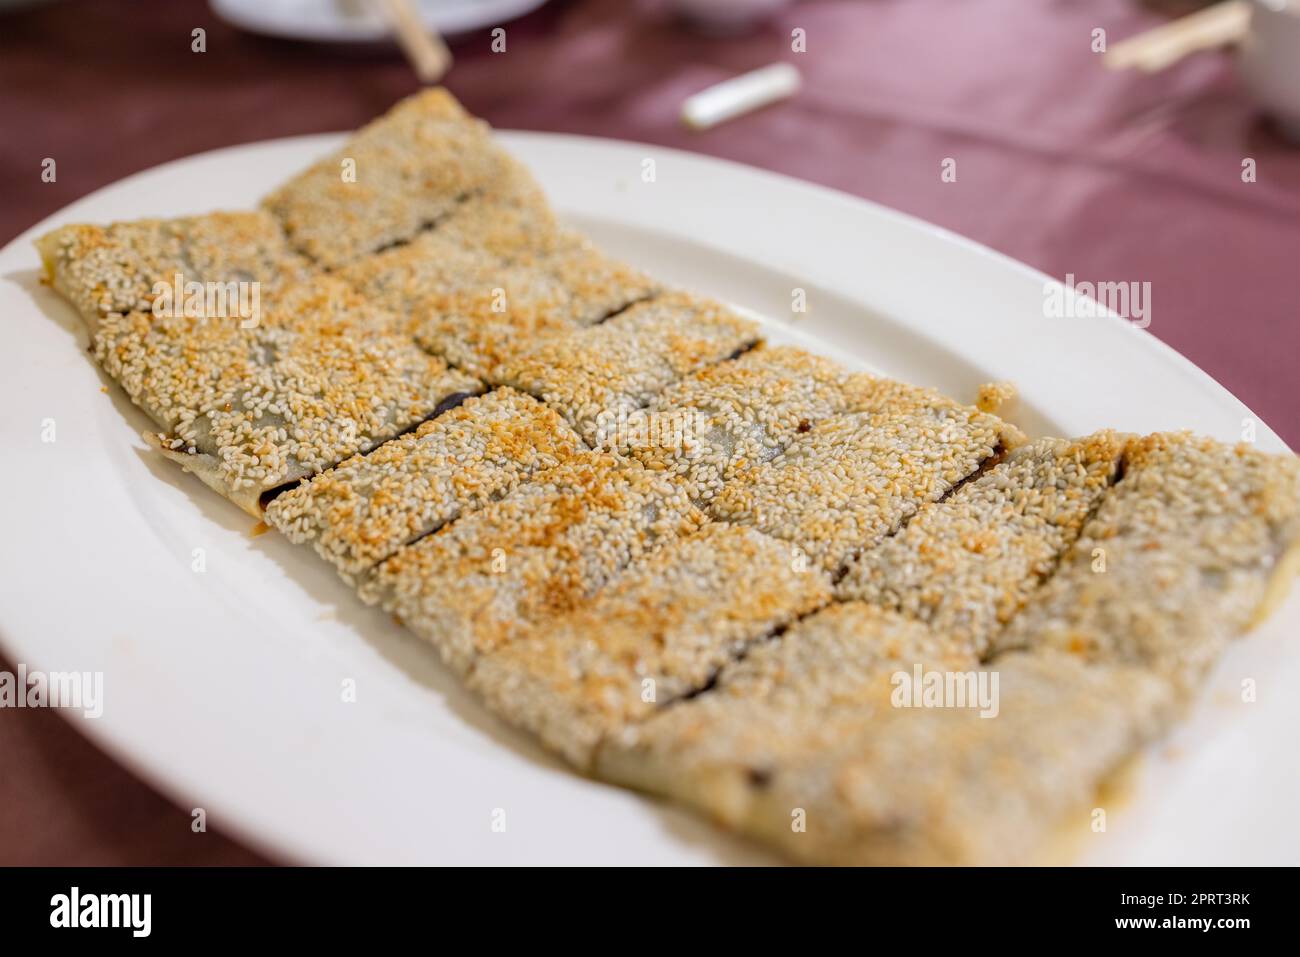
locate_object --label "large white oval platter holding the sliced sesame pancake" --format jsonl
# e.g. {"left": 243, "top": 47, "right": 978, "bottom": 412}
{"left": 0, "top": 133, "right": 1300, "bottom": 863}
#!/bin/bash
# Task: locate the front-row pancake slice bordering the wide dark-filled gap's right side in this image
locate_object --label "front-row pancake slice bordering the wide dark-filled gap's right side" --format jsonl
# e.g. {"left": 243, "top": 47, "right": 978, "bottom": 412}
{"left": 267, "top": 389, "right": 586, "bottom": 584}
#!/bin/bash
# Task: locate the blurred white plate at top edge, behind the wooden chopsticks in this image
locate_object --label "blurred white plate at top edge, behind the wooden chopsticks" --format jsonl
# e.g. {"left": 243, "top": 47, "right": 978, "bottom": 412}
{"left": 208, "top": 0, "right": 546, "bottom": 43}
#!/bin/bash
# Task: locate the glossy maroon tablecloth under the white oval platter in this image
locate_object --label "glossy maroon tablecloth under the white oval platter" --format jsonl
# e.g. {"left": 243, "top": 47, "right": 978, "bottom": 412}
{"left": 0, "top": 0, "right": 1300, "bottom": 863}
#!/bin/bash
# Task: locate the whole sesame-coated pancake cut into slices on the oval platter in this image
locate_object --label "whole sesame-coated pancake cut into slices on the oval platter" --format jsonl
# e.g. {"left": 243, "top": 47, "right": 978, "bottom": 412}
{"left": 36, "top": 90, "right": 1300, "bottom": 865}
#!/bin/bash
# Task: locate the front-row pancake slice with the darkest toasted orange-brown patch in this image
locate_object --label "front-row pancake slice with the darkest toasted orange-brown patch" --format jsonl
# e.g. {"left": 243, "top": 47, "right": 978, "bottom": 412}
{"left": 360, "top": 452, "right": 705, "bottom": 675}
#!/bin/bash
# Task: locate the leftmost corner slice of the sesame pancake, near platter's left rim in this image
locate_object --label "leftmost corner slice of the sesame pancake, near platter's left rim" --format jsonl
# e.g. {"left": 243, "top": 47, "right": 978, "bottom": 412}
{"left": 36, "top": 211, "right": 309, "bottom": 334}
